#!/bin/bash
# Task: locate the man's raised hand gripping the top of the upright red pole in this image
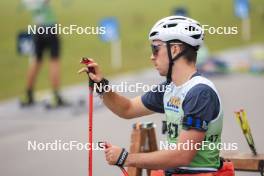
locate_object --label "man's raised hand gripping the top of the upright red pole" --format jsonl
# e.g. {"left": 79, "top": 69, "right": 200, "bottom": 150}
{"left": 78, "top": 58, "right": 103, "bottom": 82}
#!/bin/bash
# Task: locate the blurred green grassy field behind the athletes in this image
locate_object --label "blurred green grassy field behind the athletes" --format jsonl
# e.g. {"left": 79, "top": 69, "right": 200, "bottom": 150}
{"left": 0, "top": 0, "right": 264, "bottom": 99}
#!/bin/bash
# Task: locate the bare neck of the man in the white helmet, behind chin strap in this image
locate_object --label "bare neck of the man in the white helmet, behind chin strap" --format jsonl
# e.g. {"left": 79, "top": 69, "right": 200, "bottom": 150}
{"left": 171, "top": 59, "right": 197, "bottom": 86}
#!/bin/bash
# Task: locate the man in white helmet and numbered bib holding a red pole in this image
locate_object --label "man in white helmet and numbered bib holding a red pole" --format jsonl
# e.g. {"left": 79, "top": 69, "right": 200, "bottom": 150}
{"left": 80, "top": 16, "right": 234, "bottom": 176}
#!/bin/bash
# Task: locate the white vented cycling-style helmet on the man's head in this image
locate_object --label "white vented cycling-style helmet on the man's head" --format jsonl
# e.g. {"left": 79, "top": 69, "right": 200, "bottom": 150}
{"left": 149, "top": 16, "right": 204, "bottom": 49}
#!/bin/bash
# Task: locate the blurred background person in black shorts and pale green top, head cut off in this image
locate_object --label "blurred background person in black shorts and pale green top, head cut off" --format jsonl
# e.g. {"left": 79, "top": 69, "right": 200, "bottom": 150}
{"left": 20, "top": 0, "right": 66, "bottom": 107}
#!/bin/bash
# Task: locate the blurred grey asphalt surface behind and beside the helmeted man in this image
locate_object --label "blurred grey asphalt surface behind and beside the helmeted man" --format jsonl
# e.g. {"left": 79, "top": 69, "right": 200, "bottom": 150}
{"left": 0, "top": 67, "right": 264, "bottom": 176}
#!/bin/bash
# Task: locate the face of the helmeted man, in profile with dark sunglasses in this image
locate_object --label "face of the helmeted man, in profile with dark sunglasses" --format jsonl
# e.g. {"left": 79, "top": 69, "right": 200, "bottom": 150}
{"left": 151, "top": 40, "right": 169, "bottom": 76}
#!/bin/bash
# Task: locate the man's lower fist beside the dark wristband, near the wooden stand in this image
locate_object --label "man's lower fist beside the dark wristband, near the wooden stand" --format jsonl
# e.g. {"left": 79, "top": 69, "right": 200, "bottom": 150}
{"left": 105, "top": 143, "right": 122, "bottom": 165}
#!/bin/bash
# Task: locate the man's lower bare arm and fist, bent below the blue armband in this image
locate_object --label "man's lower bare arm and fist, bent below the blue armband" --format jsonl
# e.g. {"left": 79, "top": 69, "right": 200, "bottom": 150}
{"left": 106, "top": 129, "right": 205, "bottom": 169}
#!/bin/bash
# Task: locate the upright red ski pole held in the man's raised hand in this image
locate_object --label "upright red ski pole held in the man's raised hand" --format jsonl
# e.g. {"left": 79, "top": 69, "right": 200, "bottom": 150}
{"left": 81, "top": 57, "right": 95, "bottom": 176}
